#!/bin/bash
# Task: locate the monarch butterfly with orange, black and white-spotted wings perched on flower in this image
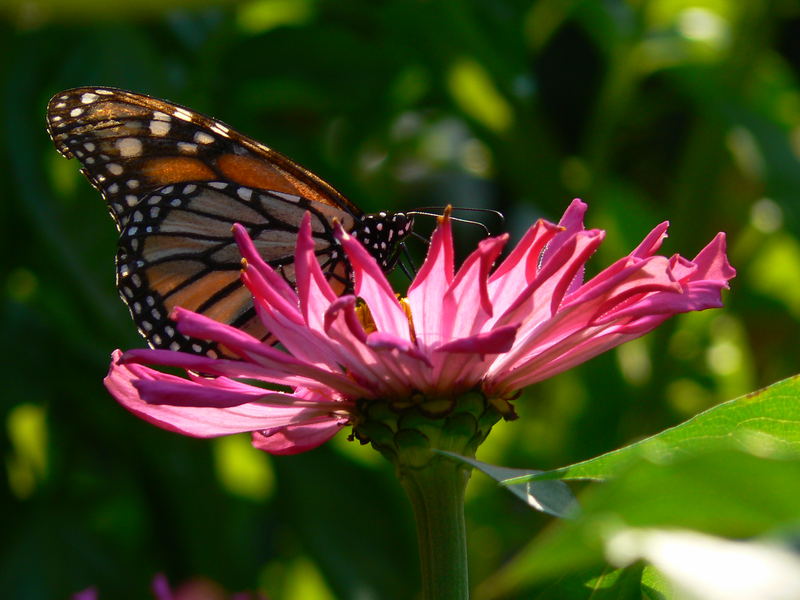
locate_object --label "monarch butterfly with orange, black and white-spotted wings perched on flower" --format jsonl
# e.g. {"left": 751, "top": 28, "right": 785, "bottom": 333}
{"left": 47, "top": 87, "right": 413, "bottom": 356}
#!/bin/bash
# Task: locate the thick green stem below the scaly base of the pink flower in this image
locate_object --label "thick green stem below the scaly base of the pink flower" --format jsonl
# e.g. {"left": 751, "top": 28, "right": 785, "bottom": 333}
{"left": 399, "top": 456, "right": 470, "bottom": 600}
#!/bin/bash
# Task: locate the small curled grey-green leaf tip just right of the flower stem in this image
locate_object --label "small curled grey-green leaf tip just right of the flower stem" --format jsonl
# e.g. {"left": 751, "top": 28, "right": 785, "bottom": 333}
{"left": 439, "top": 450, "right": 578, "bottom": 518}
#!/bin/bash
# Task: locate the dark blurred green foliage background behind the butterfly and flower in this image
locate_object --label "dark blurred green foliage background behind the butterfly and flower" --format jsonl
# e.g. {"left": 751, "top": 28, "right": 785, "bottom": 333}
{"left": 0, "top": 0, "right": 800, "bottom": 600}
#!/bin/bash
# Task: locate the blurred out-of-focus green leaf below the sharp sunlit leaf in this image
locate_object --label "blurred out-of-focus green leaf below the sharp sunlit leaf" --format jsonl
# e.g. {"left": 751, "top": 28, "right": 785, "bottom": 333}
{"left": 480, "top": 450, "right": 800, "bottom": 598}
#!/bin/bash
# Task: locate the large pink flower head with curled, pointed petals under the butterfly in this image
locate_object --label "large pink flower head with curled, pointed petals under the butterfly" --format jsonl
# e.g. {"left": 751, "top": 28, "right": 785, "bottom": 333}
{"left": 106, "top": 200, "right": 735, "bottom": 454}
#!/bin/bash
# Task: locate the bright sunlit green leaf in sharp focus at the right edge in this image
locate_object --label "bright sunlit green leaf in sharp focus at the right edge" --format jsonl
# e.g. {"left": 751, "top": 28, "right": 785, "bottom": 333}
{"left": 504, "top": 376, "right": 800, "bottom": 485}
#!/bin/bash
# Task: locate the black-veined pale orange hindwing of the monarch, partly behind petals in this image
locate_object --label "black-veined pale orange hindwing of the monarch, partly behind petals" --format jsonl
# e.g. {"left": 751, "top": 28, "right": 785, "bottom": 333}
{"left": 117, "top": 181, "right": 353, "bottom": 354}
